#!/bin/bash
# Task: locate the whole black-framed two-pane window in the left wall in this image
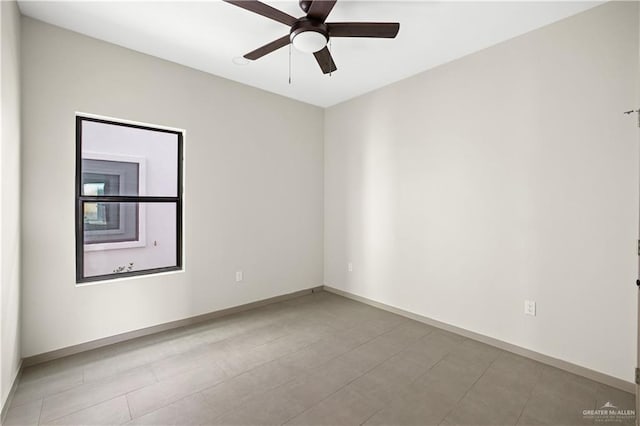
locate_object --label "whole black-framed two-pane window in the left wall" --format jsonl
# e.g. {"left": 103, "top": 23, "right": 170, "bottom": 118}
{"left": 76, "top": 116, "right": 183, "bottom": 283}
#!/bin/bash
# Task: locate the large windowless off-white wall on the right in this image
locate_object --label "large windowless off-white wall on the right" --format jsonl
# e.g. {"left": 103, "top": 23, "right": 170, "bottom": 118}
{"left": 325, "top": 2, "right": 639, "bottom": 381}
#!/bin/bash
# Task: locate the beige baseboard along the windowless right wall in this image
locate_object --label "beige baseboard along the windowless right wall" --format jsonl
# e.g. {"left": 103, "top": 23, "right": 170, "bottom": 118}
{"left": 323, "top": 285, "right": 636, "bottom": 394}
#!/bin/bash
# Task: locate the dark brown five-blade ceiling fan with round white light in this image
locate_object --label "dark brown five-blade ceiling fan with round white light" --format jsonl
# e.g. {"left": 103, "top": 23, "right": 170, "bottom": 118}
{"left": 224, "top": 0, "right": 400, "bottom": 74}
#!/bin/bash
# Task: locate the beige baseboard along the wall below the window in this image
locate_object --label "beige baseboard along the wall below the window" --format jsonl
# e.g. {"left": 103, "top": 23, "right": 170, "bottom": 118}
{"left": 22, "top": 286, "right": 322, "bottom": 367}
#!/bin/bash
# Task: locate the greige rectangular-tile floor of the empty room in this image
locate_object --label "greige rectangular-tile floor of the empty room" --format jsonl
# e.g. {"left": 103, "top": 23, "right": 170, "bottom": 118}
{"left": 6, "top": 292, "right": 634, "bottom": 426}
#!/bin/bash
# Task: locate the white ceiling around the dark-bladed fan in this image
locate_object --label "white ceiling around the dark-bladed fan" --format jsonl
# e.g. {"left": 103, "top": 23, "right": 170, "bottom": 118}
{"left": 19, "top": 0, "right": 601, "bottom": 107}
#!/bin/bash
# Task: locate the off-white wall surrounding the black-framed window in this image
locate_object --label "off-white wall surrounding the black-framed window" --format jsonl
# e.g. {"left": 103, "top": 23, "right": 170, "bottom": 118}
{"left": 22, "top": 18, "right": 323, "bottom": 357}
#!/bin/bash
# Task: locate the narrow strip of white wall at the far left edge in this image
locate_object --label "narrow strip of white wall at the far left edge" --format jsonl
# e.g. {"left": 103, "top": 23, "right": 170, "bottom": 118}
{"left": 0, "top": 1, "right": 21, "bottom": 409}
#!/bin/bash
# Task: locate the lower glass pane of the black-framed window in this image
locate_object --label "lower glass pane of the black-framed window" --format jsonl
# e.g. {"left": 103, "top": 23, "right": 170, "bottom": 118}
{"left": 83, "top": 202, "right": 177, "bottom": 277}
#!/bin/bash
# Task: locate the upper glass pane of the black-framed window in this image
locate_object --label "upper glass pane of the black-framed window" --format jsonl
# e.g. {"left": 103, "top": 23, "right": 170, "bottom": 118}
{"left": 81, "top": 120, "right": 178, "bottom": 197}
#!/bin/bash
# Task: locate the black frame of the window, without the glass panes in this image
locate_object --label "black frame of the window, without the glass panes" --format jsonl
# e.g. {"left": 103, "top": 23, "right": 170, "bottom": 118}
{"left": 75, "top": 114, "right": 184, "bottom": 284}
